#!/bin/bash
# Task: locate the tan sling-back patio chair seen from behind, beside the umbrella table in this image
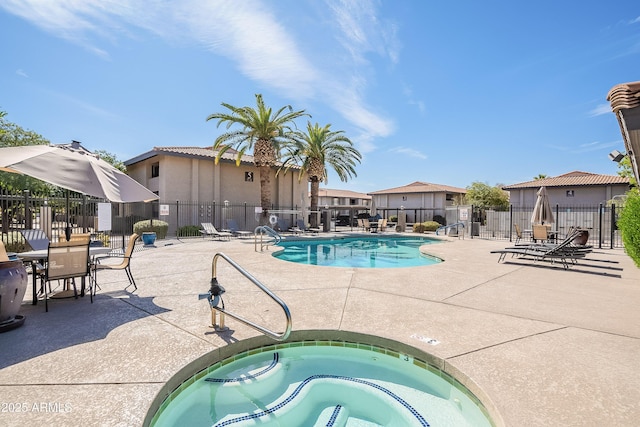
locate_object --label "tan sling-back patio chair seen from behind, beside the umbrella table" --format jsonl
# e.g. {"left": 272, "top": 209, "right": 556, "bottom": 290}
{"left": 40, "top": 241, "right": 90, "bottom": 311}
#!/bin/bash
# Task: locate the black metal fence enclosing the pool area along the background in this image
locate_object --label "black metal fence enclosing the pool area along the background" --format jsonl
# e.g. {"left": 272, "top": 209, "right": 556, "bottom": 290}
{"left": 0, "top": 192, "right": 622, "bottom": 249}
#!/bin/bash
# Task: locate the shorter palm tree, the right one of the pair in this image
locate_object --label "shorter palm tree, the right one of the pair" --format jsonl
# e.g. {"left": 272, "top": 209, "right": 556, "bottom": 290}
{"left": 281, "top": 122, "right": 362, "bottom": 227}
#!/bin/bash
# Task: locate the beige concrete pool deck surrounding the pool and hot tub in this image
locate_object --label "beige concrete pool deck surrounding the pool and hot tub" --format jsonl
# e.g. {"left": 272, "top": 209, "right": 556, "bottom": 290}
{"left": 0, "top": 233, "right": 640, "bottom": 426}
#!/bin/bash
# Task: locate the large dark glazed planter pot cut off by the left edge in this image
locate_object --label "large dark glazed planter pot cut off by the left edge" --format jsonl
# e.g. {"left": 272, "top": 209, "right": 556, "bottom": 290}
{"left": 0, "top": 259, "right": 28, "bottom": 332}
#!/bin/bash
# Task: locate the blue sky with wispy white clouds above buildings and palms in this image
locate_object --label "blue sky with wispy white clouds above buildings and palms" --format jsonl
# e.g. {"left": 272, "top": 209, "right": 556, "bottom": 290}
{"left": 0, "top": 0, "right": 640, "bottom": 193}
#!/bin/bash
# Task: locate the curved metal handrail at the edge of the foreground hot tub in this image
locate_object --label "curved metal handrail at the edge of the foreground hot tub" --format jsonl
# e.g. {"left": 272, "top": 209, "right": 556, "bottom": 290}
{"left": 199, "top": 252, "right": 291, "bottom": 341}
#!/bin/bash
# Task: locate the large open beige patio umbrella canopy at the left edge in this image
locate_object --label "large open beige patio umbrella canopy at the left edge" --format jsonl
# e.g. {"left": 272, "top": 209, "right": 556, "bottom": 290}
{"left": 0, "top": 142, "right": 158, "bottom": 203}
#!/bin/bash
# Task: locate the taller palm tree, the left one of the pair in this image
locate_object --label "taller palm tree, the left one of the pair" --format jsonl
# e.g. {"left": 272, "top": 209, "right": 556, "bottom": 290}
{"left": 207, "top": 94, "right": 308, "bottom": 224}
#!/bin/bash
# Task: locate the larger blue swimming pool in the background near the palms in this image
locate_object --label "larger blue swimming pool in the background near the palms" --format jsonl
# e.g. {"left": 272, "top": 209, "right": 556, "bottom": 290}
{"left": 273, "top": 236, "right": 442, "bottom": 268}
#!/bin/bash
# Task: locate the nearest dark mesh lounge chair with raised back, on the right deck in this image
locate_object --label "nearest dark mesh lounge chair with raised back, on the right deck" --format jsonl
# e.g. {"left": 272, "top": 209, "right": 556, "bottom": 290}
{"left": 491, "top": 231, "right": 592, "bottom": 269}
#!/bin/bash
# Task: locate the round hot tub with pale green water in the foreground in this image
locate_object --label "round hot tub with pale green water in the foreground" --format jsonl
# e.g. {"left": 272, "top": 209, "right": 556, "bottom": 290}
{"left": 145, "top": 331, "right": 493, "bottom": 427}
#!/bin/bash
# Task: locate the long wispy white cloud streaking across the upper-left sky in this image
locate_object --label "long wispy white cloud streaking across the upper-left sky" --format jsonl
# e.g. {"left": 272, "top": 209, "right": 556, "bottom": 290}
{"left": 0, "top": 0, "right": 400, "bottom": 149}
